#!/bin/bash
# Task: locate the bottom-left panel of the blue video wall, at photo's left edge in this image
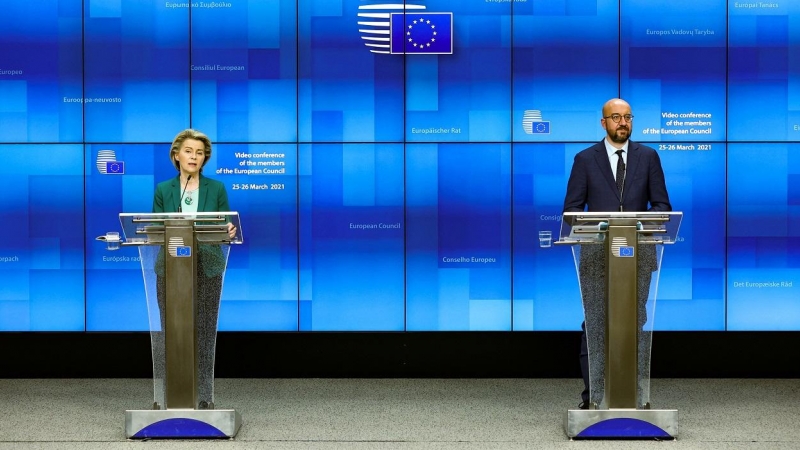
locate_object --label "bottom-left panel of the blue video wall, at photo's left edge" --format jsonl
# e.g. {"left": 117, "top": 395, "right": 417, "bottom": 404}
{"left": 0, "top": 144, "right": 85, "bottom": 331}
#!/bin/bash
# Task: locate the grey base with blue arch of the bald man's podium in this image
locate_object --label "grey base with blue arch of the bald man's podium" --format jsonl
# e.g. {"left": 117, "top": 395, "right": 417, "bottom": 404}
{"left": 564, "top": 409, "right": 678, "bottom": 439}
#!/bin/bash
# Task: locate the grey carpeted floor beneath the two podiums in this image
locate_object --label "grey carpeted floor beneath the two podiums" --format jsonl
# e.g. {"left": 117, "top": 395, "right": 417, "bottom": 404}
{"left": 0, "top": 379, "right": 800, "bottom": 450}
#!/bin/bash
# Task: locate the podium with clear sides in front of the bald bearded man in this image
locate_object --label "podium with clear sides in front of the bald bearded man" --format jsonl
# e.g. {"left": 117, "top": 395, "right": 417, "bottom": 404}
{"left": 555, "top": 212, "right": 683, "bottom": 439}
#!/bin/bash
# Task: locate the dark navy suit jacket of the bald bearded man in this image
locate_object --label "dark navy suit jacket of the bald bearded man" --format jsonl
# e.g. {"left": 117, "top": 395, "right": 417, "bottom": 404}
{"left": 564, "top": 141, "right": 672, "bottom": 212}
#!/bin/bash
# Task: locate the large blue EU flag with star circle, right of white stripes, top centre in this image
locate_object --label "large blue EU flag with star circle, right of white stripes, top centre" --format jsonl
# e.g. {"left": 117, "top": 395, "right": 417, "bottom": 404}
{"left": 390, "top": 12, "right": 453, "bottom": 55}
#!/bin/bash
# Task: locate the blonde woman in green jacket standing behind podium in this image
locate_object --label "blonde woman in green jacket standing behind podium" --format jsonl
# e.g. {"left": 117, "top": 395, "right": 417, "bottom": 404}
{"left": 153, "top": 129, "right": 236, "bottom": 409}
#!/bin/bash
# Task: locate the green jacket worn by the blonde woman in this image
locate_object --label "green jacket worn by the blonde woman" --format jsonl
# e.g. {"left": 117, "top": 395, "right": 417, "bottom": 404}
{"left": 153, "top": 175, "right": 231, "bottom": 277}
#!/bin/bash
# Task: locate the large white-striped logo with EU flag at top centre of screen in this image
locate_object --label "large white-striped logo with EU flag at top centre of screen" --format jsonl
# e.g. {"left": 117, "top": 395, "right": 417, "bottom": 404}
{"left": 358, "top": 3, "right": 453, "bottom": 55}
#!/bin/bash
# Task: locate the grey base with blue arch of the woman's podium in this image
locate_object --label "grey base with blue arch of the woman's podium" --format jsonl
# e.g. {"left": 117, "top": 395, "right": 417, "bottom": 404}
{"left": 125, "top": 409, "right": 242, "bottom": 439}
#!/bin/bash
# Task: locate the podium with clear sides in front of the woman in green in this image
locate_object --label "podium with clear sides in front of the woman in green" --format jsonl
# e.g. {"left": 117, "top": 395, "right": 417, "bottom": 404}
{"left": 110, "top": 211, "right": 242, "bottom": 439}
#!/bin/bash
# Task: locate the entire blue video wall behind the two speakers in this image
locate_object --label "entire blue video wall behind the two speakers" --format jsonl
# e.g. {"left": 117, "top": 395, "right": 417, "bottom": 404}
{"left": 0, "top": 0, "right": 800, "bottom": 331}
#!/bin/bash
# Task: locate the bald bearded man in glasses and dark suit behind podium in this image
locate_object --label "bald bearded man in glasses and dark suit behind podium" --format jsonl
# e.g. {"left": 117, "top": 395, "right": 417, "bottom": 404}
{"left": 564, "top": 98, "right": 672, "bottom": 409}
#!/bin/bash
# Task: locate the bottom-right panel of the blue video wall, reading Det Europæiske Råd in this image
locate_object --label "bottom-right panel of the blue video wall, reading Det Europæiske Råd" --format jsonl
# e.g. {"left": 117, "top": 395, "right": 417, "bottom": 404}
{"left": 727, "top": 143, "right": 800, "bottom": 330}
